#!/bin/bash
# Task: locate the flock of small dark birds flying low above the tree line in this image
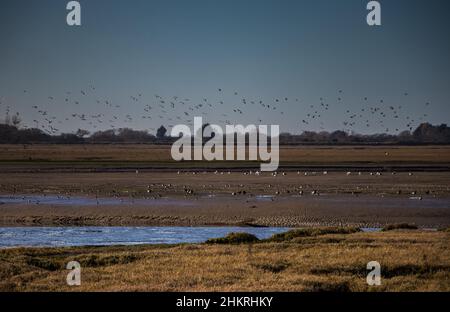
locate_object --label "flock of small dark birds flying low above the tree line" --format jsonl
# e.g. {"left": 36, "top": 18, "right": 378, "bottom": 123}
{"left": 0, "top": 85, "right": 431, "bottom": 135}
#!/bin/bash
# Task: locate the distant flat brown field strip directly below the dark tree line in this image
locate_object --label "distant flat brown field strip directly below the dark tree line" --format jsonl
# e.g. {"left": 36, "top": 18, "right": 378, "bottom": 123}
{"left": 0, "top": 144, "right": 450, "bottom": 170}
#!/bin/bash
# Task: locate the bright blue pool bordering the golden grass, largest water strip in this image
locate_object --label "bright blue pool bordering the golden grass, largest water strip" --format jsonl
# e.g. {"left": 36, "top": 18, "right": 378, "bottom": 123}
{"left": 0, "top": 226, "right": 289, "bottom": 248}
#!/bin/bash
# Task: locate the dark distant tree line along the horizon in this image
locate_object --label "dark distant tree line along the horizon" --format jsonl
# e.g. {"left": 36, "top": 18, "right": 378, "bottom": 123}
{"left": 0, "top": 122, "right": 450, "bottom": 145}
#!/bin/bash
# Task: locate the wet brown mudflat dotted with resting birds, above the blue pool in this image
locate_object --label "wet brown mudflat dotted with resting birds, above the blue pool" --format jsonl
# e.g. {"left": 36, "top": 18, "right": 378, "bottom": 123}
{"left": 0, "top": 170, "right": 450, "bottom": 228}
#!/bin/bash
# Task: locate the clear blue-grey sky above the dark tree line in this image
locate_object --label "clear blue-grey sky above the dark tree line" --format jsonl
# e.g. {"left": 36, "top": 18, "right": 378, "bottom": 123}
{"left": 0, "top": 0, "right": 450, "bottom": 133}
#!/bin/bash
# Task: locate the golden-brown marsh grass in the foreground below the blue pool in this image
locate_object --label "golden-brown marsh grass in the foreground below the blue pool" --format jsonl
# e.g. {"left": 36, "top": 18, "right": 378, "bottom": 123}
{"left": 0, "top": 231, "right": 450, "bottom": 292}
